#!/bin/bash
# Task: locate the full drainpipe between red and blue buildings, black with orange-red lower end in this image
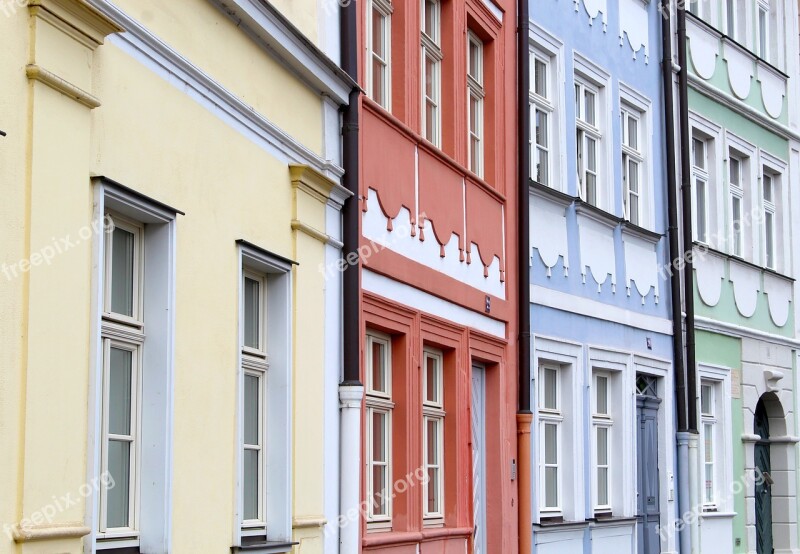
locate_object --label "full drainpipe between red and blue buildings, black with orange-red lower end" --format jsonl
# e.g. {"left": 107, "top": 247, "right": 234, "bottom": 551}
{"left": 517, "top": 0, "right": 533, "bottom": 554}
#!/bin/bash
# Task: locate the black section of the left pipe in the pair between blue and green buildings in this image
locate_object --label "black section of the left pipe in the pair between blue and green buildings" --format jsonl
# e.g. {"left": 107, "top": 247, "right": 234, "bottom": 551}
{"left": 661, "top": 2, "right": 687, "bottom": 432}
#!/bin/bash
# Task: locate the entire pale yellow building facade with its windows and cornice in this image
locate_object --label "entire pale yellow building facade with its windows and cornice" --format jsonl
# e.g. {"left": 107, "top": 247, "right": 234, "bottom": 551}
{"left": 0, "top": 0, "right": 354, "bottom": 554}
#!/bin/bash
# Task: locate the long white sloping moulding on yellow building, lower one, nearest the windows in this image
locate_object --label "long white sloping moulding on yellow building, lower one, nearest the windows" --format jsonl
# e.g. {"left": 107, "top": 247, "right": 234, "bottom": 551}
{"left": 89, "top": 0, "right": 344, "bottom": 179}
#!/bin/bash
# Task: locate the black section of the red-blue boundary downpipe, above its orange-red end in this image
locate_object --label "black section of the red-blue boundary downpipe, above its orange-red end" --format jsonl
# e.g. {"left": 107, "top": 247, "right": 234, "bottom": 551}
{"left": 517, "top": 0, "right": 531, "bottom": 414}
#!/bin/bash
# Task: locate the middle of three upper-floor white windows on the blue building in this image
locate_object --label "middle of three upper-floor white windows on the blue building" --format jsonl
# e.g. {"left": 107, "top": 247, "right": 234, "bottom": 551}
{"left": 575, "top": 76, "right": 603, "bottom": 206}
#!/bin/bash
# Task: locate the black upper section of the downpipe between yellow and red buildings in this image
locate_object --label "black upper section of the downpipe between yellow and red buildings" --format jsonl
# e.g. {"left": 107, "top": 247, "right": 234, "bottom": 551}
{"left": 339, "top": 2, "right": 361, "bottom": 385}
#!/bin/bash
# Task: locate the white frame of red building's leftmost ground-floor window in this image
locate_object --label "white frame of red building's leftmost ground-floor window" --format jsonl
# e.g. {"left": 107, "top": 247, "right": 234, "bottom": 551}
{"left": 364, "top": 330, "right": 394, "bottom": 530}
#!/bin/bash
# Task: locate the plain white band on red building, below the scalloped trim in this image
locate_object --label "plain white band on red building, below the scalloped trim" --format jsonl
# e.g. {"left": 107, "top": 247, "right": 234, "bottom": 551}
{"left": 361, "top": 269, "right": 506, "bottom": 339}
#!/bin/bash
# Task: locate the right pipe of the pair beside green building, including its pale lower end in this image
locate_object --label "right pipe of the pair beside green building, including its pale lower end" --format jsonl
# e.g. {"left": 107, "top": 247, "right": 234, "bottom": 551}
{"left": 678, "top": 3, "right": 700, "bottom": 553}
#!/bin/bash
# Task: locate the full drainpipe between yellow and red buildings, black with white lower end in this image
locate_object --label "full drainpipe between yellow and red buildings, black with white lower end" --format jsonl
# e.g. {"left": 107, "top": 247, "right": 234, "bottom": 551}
{"left": 339, "top": 2, "right": 364, "bottom": 554}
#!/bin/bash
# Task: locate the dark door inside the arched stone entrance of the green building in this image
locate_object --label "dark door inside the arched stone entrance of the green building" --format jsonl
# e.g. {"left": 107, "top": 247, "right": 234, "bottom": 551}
{"left": 753, "top": 398, "right": 774, "bottom": 554}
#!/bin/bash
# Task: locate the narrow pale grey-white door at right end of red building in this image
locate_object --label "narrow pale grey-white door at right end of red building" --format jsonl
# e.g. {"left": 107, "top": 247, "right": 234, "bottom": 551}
{"left": 472, "top": 365, "right": 486, "bottom": 554}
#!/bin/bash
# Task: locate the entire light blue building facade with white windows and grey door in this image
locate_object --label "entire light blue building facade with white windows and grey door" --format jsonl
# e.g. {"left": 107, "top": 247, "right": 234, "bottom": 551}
{"left": 530, "top": 0, "right": 677, "bottom": 554}
